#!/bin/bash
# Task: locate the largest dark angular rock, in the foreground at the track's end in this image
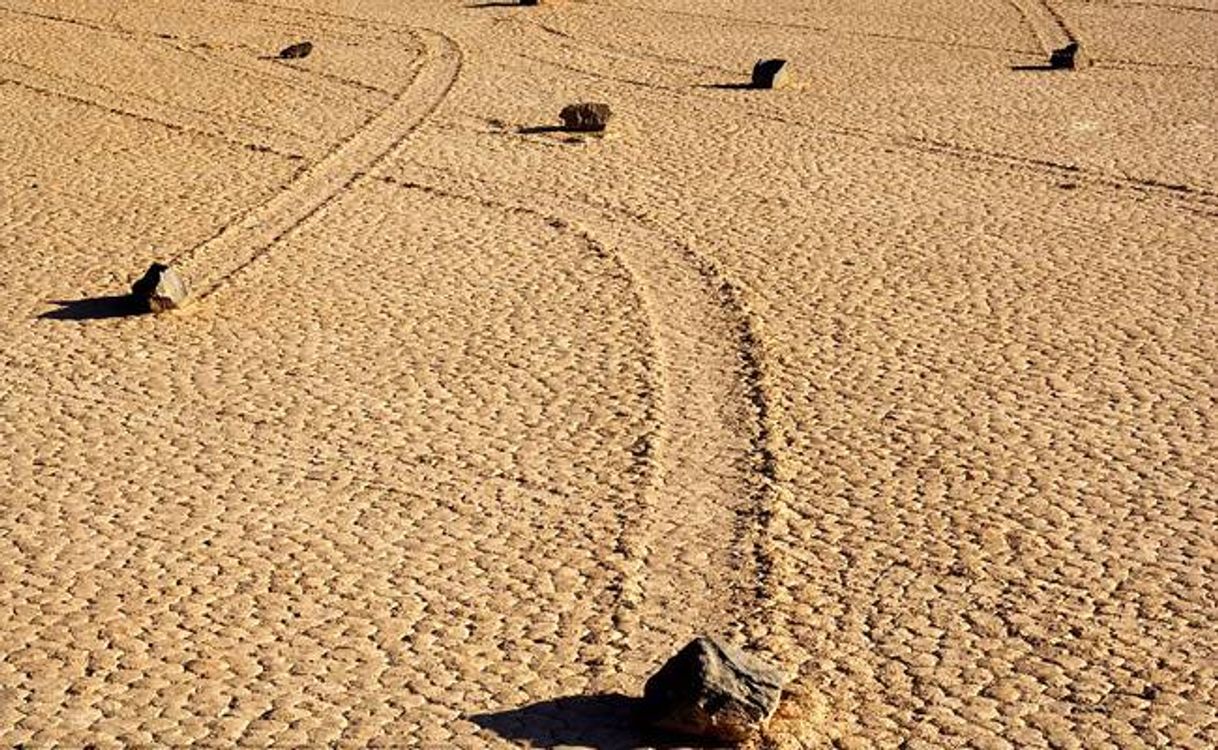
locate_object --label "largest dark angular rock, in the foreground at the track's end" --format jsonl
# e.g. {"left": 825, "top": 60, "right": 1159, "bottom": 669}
{"left": 642, "top": 637, "right": 786, "bottom": 743}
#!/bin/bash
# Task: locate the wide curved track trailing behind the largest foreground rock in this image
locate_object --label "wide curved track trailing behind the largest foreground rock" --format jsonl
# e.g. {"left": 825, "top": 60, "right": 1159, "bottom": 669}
{"left": 369, "top": 164, "right": 803, "bottom": 688}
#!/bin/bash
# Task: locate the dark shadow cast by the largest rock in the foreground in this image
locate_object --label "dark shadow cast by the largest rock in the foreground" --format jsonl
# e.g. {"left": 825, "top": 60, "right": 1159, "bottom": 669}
{"left": 469, "top": 693, "right": 719, "bottom": 750}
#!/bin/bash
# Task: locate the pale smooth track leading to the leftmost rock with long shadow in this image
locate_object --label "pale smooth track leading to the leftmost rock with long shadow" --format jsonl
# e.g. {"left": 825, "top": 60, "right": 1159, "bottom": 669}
{"left": 169, "top": 29, "right": 462, "bottom": 298}
